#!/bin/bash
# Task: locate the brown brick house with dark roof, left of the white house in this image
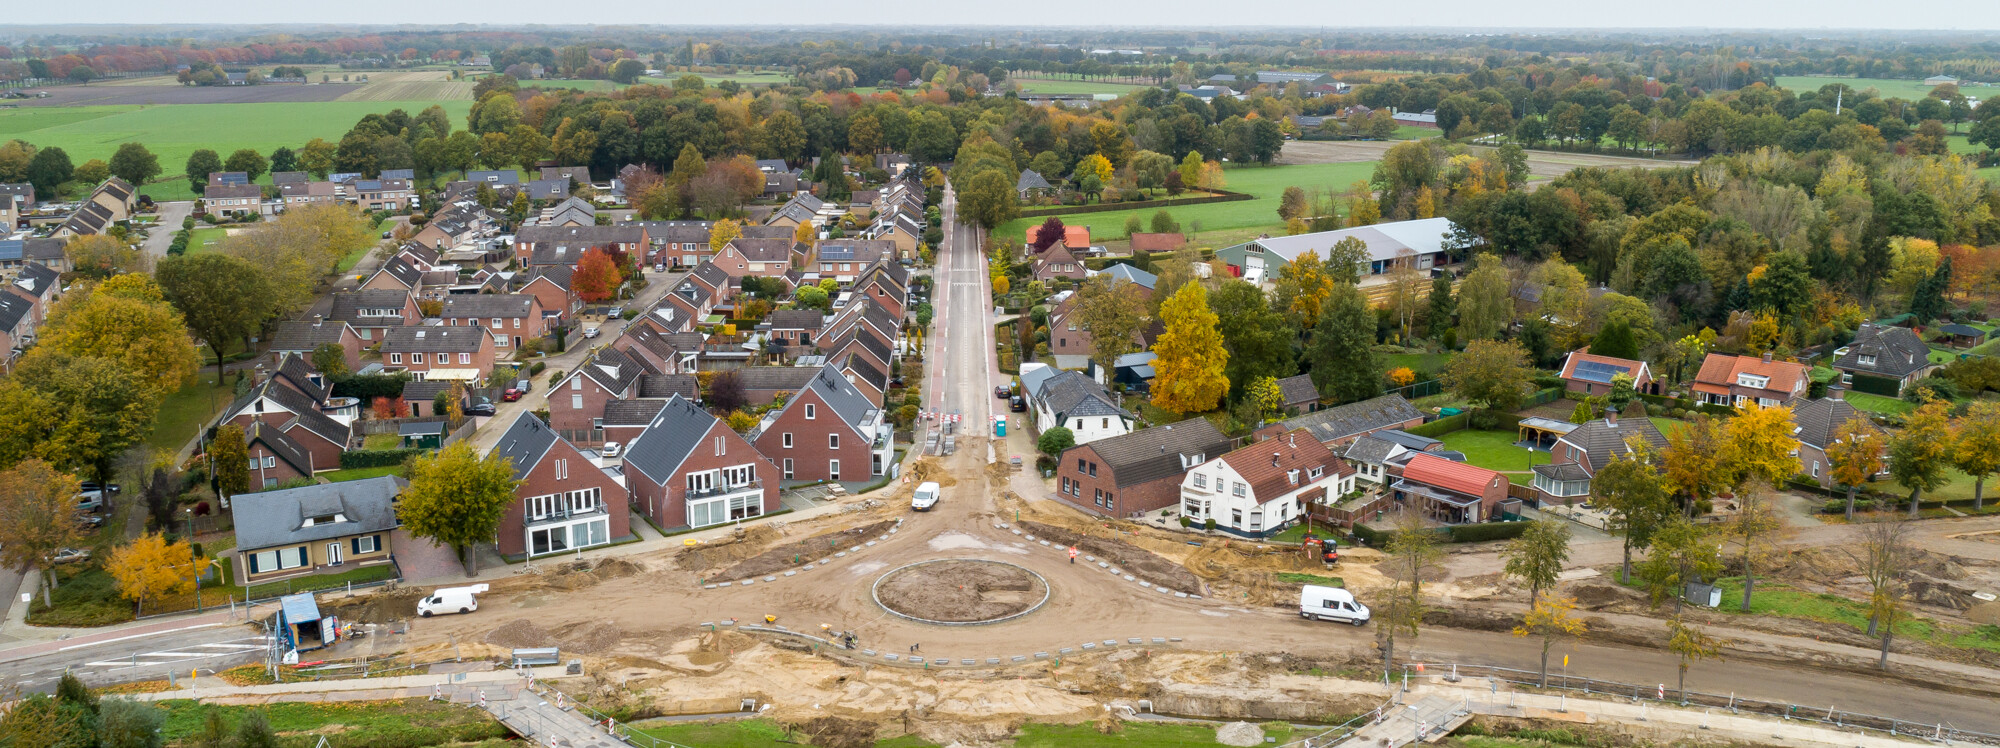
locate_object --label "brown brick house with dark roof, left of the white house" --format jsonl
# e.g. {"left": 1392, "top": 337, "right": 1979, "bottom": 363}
{"left": 1056, "top": 418, "right": 1232, "bottom": 516}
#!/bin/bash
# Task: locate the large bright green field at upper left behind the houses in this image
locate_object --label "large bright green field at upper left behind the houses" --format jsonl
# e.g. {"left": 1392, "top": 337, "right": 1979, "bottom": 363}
{"left": 0, "top": 100, "right": 472, "bottom": 200}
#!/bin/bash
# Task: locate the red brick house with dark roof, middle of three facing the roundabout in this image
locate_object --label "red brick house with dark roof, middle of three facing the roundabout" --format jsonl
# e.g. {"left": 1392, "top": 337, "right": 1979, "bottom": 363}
{"left": 624, "top": 396, "right": 778, "bottom": 530}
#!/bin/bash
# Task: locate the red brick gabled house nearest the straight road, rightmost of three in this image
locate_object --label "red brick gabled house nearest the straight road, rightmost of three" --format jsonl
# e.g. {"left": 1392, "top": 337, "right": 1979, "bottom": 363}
{"left": 750, "top": 366, "right": 896, "bottom": 480}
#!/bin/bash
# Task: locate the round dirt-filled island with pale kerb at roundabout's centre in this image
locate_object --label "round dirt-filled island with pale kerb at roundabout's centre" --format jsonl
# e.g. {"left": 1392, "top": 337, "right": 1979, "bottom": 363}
{"left": 874, "top": 558, "right": 1048, "bottom": 626}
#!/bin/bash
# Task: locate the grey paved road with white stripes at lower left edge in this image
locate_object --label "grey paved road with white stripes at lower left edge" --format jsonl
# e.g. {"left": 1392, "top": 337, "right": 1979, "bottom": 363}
{"left": 0, "top": 624, "right": 266, "bottom": 692}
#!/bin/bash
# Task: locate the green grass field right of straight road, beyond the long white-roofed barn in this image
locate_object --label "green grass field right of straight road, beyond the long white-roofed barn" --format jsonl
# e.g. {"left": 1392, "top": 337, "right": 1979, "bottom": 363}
{"left": 994, "top": 162, "right": 1374, "bottom": 248}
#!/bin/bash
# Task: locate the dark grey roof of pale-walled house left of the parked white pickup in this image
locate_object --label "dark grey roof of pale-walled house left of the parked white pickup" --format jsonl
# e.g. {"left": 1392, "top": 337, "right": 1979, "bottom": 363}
{"left": 230, "top": 476, "right": 408, "bottom": 550}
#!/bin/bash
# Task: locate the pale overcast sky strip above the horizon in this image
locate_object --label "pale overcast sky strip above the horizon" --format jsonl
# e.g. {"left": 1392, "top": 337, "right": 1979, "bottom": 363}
{"left": 11, "top": 0, "right": 2000, "bottom": 30}
